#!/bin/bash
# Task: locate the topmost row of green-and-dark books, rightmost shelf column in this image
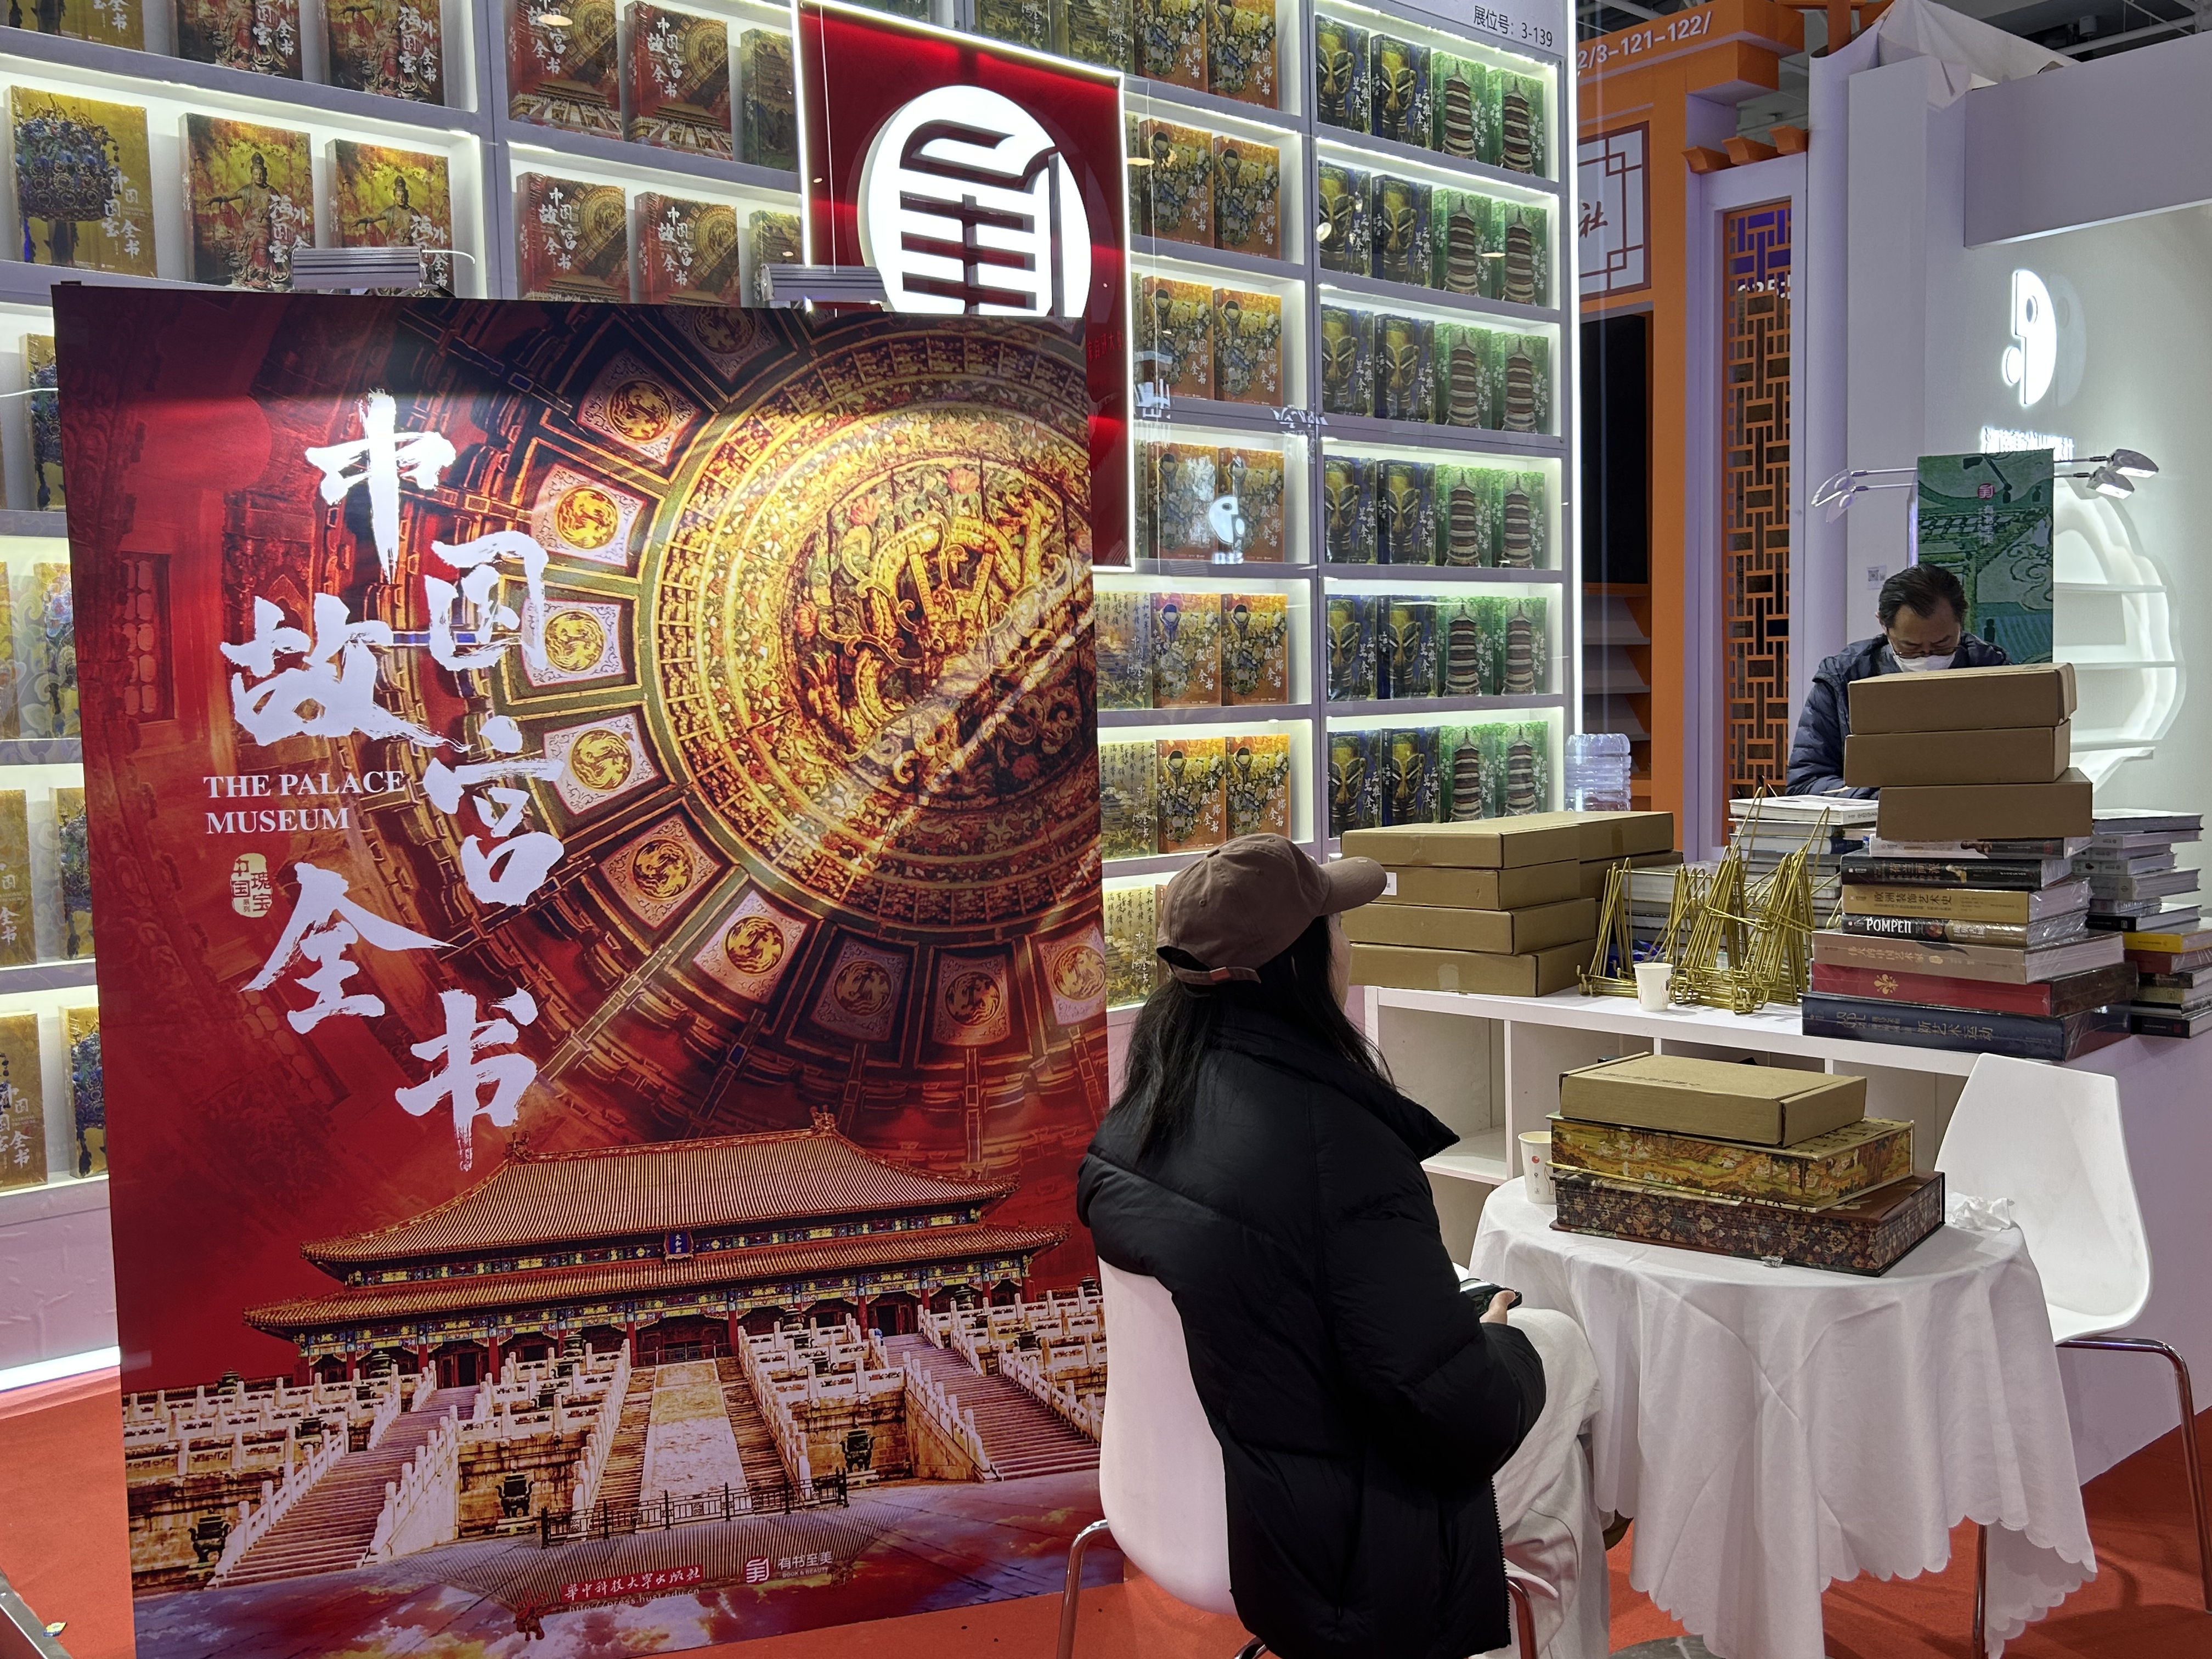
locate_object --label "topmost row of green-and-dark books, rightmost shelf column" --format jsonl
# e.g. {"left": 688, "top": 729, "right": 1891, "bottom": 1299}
{"left": 1314, "top": 15, "right": 1550, "bottom": 175}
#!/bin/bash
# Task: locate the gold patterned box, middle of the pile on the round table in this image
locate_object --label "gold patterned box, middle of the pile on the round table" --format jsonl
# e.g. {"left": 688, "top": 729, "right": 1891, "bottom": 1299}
{"left": 1550, "top": 1117, "right": 1914, "bottom": 1207}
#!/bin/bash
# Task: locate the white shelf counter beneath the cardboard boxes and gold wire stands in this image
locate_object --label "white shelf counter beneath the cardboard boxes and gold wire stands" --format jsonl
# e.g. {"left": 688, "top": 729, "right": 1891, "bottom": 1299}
{"left": 1354, "top": 986, "right": 1976, "bottom": 1261}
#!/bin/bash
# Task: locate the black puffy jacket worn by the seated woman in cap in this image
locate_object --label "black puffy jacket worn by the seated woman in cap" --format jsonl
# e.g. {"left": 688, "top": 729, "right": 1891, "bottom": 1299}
{"left": 1075, "top": 1007, "right": 1544, "bottom": 1659}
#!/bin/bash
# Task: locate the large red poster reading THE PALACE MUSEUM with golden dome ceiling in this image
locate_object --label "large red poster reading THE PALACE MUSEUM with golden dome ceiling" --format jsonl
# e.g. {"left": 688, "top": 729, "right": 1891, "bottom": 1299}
{"left": 55, "top": 287, "right": 1106, "bottom": 1659}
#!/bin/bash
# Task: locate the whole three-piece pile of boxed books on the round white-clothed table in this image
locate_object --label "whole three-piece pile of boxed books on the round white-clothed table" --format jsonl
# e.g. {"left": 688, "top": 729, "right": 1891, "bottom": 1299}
{"left": 1548, "top": 1057, "right": 1942, "bottom": 1276}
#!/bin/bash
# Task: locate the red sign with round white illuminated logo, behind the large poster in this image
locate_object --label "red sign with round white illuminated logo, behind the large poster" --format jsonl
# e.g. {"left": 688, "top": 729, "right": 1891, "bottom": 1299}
{"left": 797, "top": 0, "right": 1130, "bottom": 564}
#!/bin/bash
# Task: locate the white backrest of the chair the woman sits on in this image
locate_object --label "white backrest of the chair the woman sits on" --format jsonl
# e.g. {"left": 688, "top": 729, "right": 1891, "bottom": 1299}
{"left": 1099, "top": 1261, "right": 1237, "bottom": 1617}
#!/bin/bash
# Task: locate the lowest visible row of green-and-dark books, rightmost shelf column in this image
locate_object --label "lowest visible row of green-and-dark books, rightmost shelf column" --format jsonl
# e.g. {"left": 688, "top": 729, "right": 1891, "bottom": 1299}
{"left": 1329, "top": 721, "right": 1550, "bottom": 836}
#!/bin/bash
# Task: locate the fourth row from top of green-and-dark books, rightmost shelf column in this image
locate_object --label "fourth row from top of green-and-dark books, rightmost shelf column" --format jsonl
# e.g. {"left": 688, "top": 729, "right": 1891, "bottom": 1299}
{"left": 1321, "top": 462, "right": 1550, "bottom": 571}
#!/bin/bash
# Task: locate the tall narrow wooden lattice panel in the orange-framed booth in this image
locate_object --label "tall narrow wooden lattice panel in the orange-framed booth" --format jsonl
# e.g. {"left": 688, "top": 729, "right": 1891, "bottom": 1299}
{"left": 1721, "top": 201, "right": 1790, "bottom": 797}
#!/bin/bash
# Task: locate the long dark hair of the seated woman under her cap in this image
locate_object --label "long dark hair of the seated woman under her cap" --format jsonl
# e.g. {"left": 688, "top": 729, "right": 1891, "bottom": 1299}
{"left": 1113, "top": 916, "right": 1389, "bottom": 1157}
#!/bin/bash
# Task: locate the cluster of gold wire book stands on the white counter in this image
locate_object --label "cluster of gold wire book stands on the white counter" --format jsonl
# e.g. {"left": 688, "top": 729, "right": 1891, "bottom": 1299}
{"left": 1582, "top": 792, "right": 1827, "bottom": 1013}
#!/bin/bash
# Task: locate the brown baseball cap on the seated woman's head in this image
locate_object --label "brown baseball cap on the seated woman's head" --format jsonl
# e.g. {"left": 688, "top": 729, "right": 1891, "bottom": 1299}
{"left": 1155, "top": 836, "right": 1385, "bottom": 984}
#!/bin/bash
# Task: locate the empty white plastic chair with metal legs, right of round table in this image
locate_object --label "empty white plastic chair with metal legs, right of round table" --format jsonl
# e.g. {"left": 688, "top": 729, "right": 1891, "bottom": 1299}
{"left": 1936, "top": 1055, "right": 2212, "bottom": 1659}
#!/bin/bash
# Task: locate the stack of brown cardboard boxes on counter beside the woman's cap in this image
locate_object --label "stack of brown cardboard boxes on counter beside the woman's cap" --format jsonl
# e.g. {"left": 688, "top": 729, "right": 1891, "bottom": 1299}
{"left": 1342, "top": 812, "right": 1674, "bottom": 995}
